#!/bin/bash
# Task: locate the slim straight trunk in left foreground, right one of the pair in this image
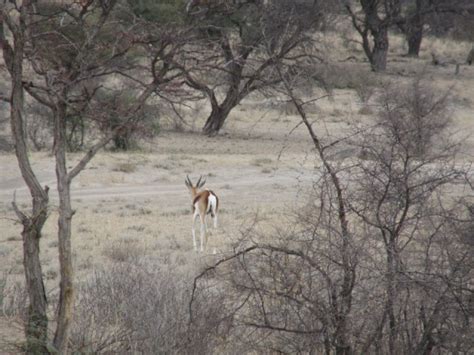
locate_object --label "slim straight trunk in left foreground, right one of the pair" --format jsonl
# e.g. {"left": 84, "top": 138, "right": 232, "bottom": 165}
{"left": 54, "top": 101, "right": 74, "bottom": 354}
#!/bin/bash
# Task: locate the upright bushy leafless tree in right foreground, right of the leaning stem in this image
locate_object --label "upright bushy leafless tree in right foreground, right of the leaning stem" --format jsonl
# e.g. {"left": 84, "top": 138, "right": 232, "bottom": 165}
{"left": 351, "top": 81, "right": 472, "bottom": 354}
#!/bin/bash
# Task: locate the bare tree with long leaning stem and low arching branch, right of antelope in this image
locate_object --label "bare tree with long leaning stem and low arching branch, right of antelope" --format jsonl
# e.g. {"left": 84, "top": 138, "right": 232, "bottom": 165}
{"left": 191, "top": 27, "right": 358, "bottom": 354}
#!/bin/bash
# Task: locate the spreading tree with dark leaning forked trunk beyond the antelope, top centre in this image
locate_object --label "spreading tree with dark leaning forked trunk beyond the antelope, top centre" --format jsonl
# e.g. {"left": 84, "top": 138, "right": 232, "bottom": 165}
{"left": 186, "top": 0, "right": 320, "bottom": 135}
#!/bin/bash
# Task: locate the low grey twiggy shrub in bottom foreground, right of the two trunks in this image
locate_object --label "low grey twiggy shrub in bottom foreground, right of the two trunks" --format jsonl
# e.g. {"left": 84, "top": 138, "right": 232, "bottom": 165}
{"left": 71, "top": 258, "right": 230, "bottom": 354}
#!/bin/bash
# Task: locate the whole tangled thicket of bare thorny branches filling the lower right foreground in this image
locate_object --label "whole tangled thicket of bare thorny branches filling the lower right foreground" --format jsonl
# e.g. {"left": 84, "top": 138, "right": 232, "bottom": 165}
{"left": 191, "top": 48, "right": 474, "bottom": 354}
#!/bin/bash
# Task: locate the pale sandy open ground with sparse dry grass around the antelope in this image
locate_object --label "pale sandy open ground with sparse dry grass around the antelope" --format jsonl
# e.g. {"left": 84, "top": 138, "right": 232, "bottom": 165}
{"left": 0, "top": 34, "right": 474, "bottom": 353}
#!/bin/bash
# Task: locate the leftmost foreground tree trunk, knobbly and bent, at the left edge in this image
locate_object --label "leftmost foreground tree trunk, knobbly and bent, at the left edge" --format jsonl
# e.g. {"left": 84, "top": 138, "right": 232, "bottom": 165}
{"left": 0, "top": 1, "right": 48, "bottom": 354}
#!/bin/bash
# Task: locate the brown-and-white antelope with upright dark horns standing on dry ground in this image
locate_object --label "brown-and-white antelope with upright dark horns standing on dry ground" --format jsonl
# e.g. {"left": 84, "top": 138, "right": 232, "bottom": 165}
{"left": 184, "top": 175, "right": 219, "bottom": 252}
